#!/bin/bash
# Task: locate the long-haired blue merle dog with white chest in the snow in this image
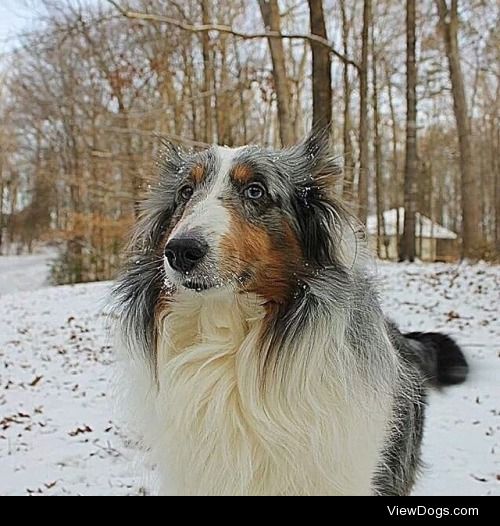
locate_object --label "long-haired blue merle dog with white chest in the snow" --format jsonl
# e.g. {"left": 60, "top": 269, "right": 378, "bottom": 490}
{"left": 115, "top": 133, "right": 468, "bottom": 496}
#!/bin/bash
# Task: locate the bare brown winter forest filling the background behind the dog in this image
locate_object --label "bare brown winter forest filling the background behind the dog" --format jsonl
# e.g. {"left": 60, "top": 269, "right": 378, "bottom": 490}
{"left": 0, "top": 0, "right": 500, "bottom": 283}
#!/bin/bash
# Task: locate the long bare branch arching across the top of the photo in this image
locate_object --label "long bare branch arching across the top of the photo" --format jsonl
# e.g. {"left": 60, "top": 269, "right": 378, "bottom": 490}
{"left": 107, "top": 0, "right": 360, "bottom": 71}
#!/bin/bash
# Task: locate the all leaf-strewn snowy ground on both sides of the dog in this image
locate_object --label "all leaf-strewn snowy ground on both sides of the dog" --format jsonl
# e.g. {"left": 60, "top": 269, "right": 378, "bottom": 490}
{"left": 0, "top": 258, "right": 500, "bottom": 495}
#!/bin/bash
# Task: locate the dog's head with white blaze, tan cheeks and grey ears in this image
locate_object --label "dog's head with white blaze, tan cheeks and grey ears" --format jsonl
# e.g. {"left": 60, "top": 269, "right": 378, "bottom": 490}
{"left": 131, "top": 134, "right": 354, "bottom": 303}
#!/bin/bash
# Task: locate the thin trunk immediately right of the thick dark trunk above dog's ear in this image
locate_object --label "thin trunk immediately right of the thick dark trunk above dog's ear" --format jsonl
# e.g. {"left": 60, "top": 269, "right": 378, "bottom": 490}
{"left": 340, "top": 0, "right": 354, "bottom": 197}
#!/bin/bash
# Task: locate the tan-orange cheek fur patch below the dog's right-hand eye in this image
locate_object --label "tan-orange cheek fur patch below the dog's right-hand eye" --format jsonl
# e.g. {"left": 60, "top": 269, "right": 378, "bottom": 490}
{"left": 221, "top": 210, "right": 302, "bottom": 303}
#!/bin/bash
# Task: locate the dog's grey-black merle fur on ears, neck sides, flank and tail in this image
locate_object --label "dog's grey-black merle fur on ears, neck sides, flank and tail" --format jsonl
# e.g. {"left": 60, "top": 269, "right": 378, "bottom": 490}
{"left": 116, "top": 134, "right": 467, "bottom": 495}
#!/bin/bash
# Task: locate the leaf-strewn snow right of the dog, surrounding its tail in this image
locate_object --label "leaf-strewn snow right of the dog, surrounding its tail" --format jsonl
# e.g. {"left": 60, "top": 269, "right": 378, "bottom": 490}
{"left": 379, "top": 263, "right": 500, "bottom": 495}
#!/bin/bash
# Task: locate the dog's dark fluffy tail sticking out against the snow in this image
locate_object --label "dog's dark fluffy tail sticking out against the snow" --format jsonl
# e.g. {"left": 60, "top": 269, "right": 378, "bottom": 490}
{"left": 404, "top": 332, "right": 469, "bottom": 387}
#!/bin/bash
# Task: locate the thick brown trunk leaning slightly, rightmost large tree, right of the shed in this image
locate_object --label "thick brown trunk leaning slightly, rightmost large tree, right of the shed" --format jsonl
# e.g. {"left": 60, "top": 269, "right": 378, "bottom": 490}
{"left": 436, "top": 0, "right": 482, "bottom": 259}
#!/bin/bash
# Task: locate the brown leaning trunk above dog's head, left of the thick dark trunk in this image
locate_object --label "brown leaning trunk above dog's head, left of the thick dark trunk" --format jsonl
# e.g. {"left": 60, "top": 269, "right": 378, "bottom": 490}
{"left": 259, "top": 0, "right": 295, "bottom": 146}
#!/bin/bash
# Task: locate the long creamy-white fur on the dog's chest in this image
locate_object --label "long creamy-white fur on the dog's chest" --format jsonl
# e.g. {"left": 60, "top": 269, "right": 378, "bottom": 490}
{"left": 140, "top": 293, "right": 391, "bottom": 495}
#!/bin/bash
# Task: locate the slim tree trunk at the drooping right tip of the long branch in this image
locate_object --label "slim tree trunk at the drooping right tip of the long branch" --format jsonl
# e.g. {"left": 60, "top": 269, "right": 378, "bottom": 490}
{"left": 358, "top": 0, "right": 372, "bottom": 225}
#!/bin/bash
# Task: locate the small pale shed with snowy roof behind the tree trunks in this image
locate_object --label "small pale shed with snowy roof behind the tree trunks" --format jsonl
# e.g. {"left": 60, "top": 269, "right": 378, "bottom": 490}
{"left": 367, "top": 207, "right": 460, "bottom": 262}
